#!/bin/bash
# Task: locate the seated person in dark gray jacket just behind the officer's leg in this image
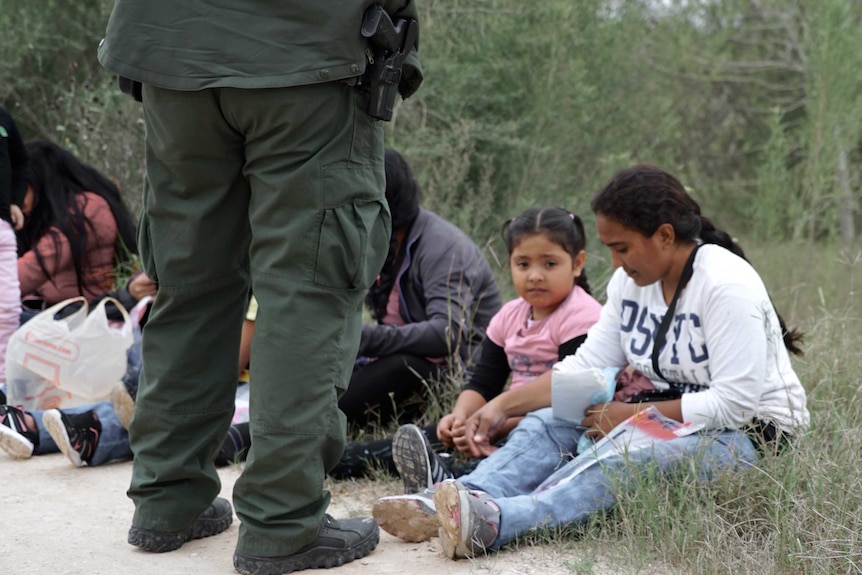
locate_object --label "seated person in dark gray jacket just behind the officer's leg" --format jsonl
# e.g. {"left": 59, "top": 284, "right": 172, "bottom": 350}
{"left": 338, "top": 149, "right": 501, "bottom": 427}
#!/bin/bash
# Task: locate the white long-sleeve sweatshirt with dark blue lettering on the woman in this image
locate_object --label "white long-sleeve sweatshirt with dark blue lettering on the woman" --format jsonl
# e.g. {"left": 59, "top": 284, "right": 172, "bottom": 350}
{"left": 554, "top": 244, "right": 809, "bottom": 433}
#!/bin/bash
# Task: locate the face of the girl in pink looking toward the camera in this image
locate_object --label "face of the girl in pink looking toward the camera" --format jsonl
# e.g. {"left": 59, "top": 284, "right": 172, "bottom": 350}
{"left": 509, "top": 233, "right": 587, "bottom": 320}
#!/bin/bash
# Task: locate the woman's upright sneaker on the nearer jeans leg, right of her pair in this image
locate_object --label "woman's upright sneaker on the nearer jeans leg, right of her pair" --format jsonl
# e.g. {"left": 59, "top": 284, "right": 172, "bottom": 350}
{"left": 434, "top": 479, "right": 500, "bottom": 559}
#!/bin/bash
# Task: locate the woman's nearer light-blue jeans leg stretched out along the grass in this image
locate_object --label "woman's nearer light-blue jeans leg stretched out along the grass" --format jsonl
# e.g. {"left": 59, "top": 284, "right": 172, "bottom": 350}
{"left": 491, "top": 431, "right": 758, "bottom": 548}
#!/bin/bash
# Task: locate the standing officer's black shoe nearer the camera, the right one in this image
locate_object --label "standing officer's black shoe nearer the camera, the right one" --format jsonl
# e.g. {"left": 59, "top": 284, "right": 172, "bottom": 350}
{"left": 233, "top": 515, "right": 380, "bottom": 575}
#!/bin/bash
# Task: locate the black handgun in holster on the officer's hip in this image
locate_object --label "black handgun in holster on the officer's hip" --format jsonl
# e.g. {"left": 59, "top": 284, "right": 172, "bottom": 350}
{"left": 360, "top": 4, "right": 419, "bottom": 122}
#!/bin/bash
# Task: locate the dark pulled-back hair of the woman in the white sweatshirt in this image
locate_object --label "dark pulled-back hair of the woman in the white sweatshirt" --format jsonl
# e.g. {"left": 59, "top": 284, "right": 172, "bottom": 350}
{"left": 591, "top": 164, "right": 803, "bottom": 355}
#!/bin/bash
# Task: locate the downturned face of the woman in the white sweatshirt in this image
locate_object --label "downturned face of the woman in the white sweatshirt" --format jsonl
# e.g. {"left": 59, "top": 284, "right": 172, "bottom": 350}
{"left": 596, "top": 214, "right": 674, "bottom": 287}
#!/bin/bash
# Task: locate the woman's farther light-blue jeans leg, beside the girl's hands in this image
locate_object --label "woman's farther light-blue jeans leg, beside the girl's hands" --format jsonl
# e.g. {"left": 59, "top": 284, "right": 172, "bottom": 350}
{"left": 458, "top": 407, "right": 583, "bottom": 497}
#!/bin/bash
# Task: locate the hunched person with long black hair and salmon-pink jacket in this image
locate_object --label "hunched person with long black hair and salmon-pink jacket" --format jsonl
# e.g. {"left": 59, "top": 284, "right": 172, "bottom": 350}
{"left": 18, "top": 140, "right": 137, "bottom": 305}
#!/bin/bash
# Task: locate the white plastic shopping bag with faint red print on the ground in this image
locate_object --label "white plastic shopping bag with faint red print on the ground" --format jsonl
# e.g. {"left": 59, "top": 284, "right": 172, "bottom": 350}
{"left": 6, "top": 297, "right": 134, "bottom": 409}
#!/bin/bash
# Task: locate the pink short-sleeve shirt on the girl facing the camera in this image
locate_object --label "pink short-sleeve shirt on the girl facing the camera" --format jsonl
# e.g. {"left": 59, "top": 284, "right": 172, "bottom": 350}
{"left": 487, "top": 286, "right": 602, "bottom": 389}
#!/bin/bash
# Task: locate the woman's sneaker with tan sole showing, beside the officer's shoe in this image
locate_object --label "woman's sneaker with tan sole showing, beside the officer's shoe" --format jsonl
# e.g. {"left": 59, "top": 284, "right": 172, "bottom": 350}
{"left": 371, "top": 487, "right": 440, "bottom": 542}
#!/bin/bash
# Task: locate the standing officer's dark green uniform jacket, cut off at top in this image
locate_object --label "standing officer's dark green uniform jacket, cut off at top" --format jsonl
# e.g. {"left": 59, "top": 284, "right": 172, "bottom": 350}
{"left": 99, "top": 0, "right": 422, "bottom": 97}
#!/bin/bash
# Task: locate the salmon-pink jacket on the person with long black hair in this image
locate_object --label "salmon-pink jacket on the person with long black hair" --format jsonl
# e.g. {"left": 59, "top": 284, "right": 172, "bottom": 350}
{"left": 18, "top": 192, "right": 117, "bottom": 305}
